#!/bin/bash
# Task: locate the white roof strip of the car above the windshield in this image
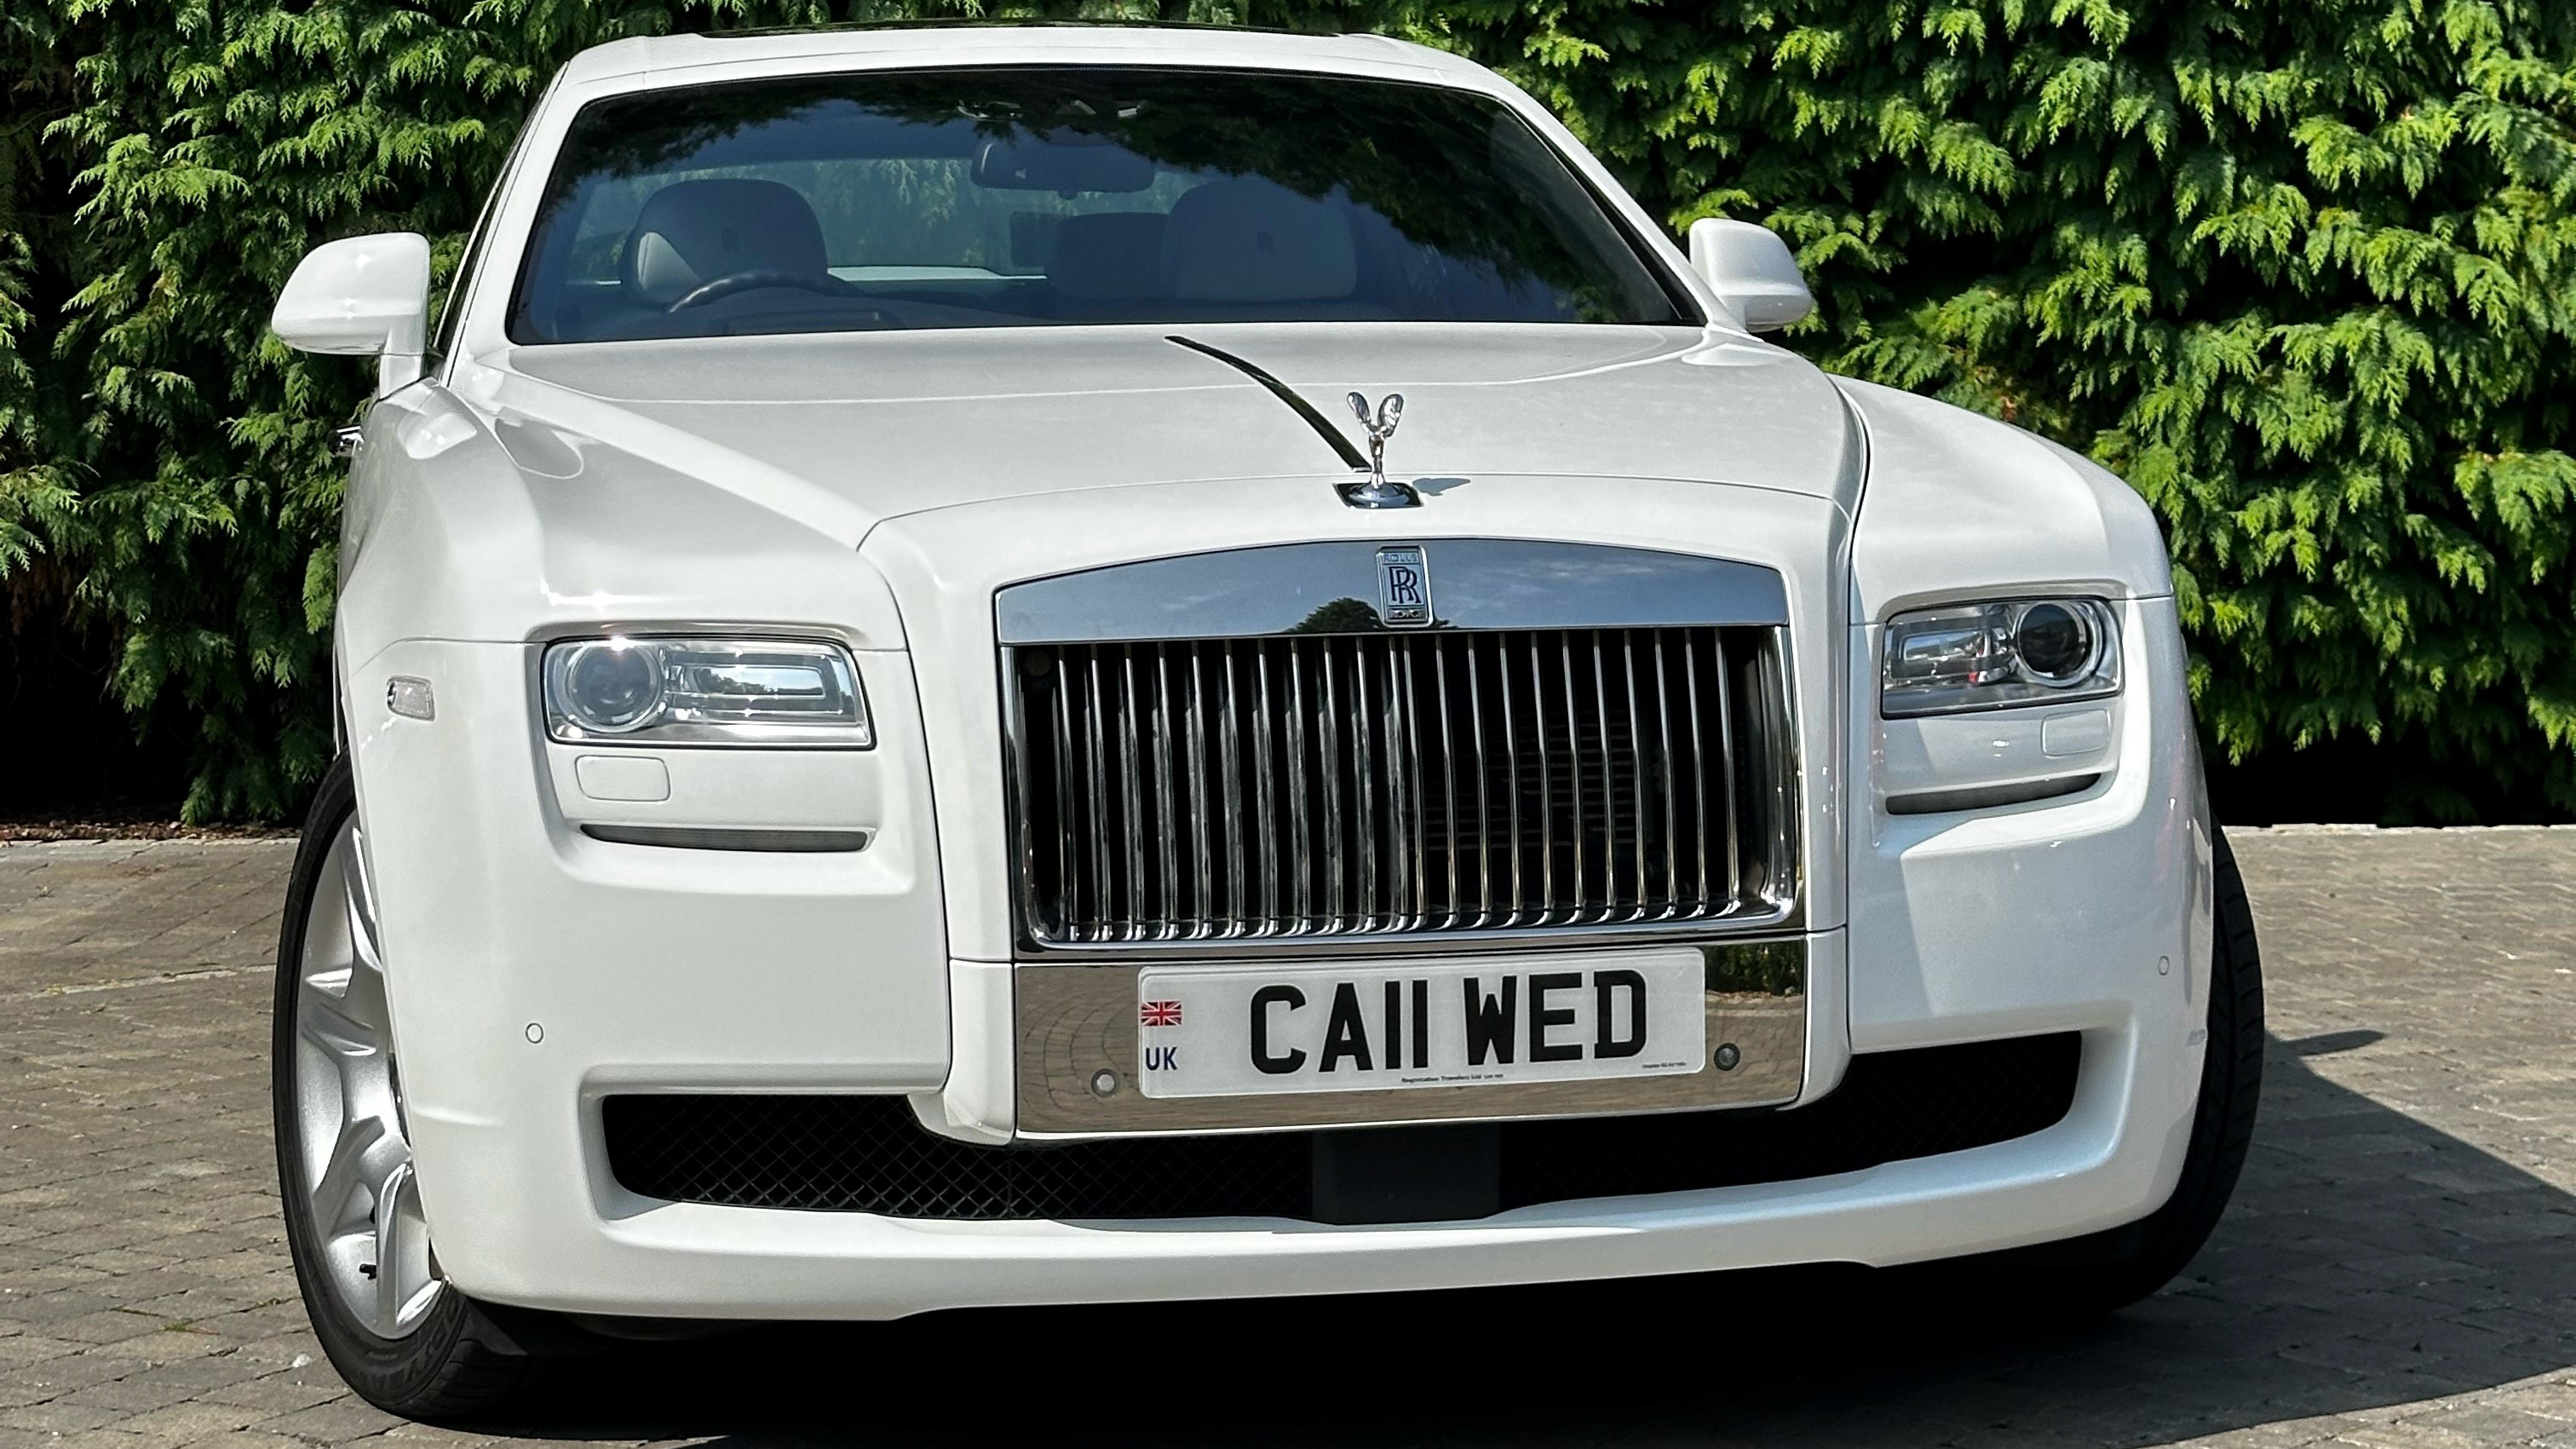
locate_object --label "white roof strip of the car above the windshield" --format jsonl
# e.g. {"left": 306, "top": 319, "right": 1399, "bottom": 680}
{"left": 561, "top": 23, "right": 1492, "bottom": 90}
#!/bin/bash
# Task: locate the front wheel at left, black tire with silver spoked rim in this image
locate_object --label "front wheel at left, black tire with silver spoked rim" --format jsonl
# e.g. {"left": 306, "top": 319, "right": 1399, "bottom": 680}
{"left": 271, "top": 758, "right": 572, "bottom": 1421}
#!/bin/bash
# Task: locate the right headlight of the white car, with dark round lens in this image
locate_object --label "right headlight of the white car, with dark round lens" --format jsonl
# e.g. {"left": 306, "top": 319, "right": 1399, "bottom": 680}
{"left": 1877, "top": 598, "right": 2120, "bottom": 719}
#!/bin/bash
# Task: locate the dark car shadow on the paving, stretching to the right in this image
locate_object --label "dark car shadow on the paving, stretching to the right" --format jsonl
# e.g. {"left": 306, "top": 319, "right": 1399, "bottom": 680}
{"left": 485, "top": 1032, "right": 2576, "bottom": 1449}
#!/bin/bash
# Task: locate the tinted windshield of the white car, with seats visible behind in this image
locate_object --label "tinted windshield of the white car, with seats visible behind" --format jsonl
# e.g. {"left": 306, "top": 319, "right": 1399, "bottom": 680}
{"left": 510, "top": 67, "right": 1698, "bottom": 343}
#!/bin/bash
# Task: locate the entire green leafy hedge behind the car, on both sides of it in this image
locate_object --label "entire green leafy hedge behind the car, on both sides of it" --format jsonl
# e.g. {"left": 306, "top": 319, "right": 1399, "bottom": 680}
{"left": 0, "top": 0, "right": 2576, "bottom": 817}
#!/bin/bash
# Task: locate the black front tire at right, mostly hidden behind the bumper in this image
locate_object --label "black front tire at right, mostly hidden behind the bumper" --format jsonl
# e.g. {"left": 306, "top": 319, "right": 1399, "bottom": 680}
{"left": 1937, "top": 825, "right": 2264, "bottom": 1320}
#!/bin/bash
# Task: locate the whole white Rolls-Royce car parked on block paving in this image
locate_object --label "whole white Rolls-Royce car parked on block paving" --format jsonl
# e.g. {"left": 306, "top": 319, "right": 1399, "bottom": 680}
{"left": 273, "top": 28, "right": 2262, "bottom": 1416}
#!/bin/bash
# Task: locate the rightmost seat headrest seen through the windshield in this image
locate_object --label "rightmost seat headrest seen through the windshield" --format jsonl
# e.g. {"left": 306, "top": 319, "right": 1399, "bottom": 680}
{"left": 1162, "top": 178, "right": 1360, "bottom": 302}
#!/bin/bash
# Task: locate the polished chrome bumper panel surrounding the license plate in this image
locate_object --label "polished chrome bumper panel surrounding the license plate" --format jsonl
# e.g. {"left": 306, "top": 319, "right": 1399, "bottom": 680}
{"left": 1012, "top": 929, "right": 1811, "bottom": 1140}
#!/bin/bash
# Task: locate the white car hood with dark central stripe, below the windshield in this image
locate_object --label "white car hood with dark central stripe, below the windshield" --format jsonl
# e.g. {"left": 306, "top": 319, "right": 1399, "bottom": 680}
{"left": 456, "top": 322, "right": 1857, "bottom": 542}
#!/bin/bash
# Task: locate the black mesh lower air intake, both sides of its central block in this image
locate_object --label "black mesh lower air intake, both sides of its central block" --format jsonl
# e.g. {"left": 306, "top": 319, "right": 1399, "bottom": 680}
{"left": 603, "top": 1034, "right": 2079, "bottom": 1220}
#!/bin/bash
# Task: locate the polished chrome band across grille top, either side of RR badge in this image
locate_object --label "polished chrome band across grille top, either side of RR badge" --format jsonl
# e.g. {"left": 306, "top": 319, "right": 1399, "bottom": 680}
{"left": 994, "top": 539, "right": 1788, "bottom": 645}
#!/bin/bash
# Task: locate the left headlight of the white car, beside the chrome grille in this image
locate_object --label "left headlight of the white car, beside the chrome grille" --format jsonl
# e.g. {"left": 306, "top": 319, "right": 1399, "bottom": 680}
{"left": 543, "top": 637, "right": 876, "bottom": 750}
